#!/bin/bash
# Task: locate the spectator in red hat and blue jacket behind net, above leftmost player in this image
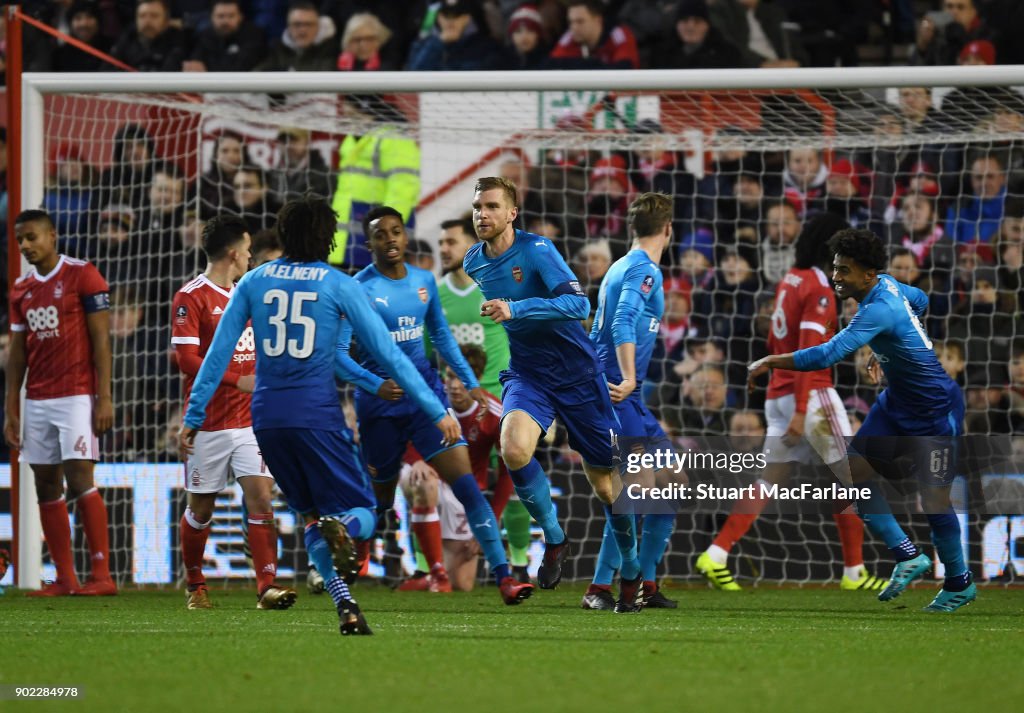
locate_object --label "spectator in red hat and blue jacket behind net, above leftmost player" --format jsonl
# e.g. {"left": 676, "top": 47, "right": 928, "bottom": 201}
{"left": 43, "top": 143, "right": 95, "bottom": 253}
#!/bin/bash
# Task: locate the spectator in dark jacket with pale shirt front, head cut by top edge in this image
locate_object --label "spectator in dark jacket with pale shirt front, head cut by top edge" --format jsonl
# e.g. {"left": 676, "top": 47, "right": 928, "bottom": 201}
{"left": 709, "top": 0, "right": 808, "bottom": 68}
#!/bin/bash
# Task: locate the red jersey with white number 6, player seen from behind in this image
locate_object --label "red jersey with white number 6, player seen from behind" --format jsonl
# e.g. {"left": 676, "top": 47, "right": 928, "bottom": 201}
{"left": 768, "top": 267, "right": 836, "bottom": 405}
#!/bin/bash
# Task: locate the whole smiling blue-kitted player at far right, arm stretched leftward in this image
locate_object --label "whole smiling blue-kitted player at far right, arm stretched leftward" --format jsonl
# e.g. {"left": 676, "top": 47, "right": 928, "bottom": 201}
{"left": 749, "top": 229, "right": 977, "bottom": 612}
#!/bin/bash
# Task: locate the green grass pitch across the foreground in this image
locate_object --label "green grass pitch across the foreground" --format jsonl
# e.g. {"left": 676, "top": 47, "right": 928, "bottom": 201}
{"left": 0, "top": 585, "right": 1024, "bottom": 713}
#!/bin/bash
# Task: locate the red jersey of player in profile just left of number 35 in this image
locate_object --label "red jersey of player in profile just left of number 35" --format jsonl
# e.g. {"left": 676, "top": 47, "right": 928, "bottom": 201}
{"left": 171, "top": 275, "right": 256, "bottom": 430}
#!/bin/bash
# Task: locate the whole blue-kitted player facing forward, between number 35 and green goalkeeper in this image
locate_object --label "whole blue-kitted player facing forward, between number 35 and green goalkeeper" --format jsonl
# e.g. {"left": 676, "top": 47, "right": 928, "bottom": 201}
{"left": 338, "top": 206, "right": 534, "bottom": 604}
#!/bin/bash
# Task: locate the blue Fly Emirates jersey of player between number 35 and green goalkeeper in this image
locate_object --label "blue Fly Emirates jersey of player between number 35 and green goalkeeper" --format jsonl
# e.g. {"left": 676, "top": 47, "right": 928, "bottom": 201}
{"left": 339, "top": 264, "right": 480, "bottom": 393}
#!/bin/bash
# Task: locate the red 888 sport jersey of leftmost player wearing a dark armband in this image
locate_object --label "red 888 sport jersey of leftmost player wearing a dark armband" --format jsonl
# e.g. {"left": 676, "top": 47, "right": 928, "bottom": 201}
{"left": 10, "top": 255, "right": 111, "bottom": 400}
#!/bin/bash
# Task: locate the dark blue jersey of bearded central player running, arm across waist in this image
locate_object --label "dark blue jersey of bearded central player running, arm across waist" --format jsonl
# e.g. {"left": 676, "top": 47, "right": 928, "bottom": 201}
{"left": 463, "top": 230, "right": 604, "bottom": 389}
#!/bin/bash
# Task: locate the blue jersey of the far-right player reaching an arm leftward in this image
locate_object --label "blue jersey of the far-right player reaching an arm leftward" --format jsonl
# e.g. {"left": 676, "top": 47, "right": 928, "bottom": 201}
{"left": 793, "top": 275, "right": 958, "bottom": 426}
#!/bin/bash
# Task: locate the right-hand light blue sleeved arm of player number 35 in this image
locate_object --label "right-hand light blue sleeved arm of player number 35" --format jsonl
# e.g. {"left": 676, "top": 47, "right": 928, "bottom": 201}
{"left": 339, "top": 281, "right": 449, "bottom": 423}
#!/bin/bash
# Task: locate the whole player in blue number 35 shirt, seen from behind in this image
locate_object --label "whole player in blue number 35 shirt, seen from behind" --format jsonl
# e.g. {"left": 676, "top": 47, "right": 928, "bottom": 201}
{"left": 179, "top": 198, "right": 460, "bottom": 635}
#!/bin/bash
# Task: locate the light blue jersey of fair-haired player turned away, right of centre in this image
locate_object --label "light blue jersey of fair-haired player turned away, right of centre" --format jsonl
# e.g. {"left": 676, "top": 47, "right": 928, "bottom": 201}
{"left": 590, "top": 250, "right": 665, "bottom": 387}
